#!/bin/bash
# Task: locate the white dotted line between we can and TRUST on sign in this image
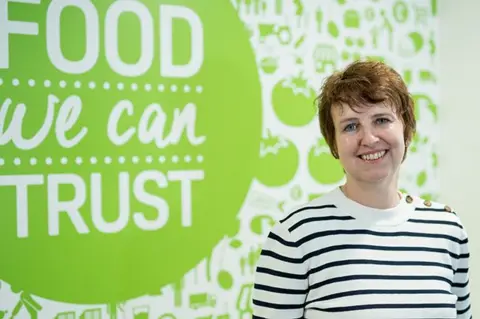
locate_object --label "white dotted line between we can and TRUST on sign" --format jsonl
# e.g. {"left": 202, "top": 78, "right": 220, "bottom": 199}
{"left": 0, "top": 155, "right": 203, "bottom": 166}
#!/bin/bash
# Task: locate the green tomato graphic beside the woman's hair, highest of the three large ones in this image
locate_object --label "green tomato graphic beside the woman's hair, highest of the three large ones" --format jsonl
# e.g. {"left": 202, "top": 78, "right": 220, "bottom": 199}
{"left": 272, "top": 75, "right": 315, "bottom": 127}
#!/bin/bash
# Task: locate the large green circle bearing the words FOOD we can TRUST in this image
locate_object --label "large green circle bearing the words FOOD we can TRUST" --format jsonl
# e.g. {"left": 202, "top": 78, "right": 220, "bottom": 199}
{"left": 0, "top": 0, "right": 262, "bottom": 304}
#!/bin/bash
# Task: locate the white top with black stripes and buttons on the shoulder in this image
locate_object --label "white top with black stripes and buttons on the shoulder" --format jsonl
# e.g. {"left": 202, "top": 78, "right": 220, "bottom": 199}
{"left": 252, "top": 188, "right": 472, "bottom": 319}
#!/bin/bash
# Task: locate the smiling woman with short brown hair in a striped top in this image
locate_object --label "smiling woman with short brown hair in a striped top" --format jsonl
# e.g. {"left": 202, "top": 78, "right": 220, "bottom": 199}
{"left": 253, "top": 62, "right": 471, "bottom": 319}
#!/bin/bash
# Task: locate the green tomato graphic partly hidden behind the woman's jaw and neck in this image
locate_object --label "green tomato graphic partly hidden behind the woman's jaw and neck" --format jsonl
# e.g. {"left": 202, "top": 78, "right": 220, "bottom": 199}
{"left": 308, "top": 138, "right": 345, "bottom": 184}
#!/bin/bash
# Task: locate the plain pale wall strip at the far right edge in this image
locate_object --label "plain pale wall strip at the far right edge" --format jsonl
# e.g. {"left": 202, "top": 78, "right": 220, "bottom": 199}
{"left": 438, "top": 0, "right": 480, "bottom": 314}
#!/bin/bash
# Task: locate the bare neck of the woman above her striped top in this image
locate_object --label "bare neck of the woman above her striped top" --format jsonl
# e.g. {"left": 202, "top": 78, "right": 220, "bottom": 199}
{"left": 341, "top": 180, "right": 401, "bottom": 209}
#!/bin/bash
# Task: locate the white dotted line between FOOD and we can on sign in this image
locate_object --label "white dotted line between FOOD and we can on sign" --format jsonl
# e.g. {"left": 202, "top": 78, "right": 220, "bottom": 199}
{"left": 0, "top": 78, "right": 203, "bottom": 93}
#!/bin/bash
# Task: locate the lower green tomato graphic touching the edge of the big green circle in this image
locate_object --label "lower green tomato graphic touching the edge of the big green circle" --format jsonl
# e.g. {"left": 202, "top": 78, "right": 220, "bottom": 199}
{"left": 256, "top": 131, "right": 299, "bottom": 187}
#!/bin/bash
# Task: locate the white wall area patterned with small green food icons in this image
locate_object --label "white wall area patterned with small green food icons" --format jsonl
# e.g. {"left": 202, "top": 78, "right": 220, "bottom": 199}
{"left": 0, "top": 0, "right": 438, "bottom": 319}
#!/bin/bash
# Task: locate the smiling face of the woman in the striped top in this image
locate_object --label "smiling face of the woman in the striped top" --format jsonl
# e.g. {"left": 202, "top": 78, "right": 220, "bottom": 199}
{"left": 332, "top": 104, "right": 405, "bottom": 183}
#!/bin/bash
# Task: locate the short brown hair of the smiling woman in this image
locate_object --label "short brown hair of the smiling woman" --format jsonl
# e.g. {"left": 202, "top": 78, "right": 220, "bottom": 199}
{"left": 316, "top": 61, "right": 416, "bottom": 158}
